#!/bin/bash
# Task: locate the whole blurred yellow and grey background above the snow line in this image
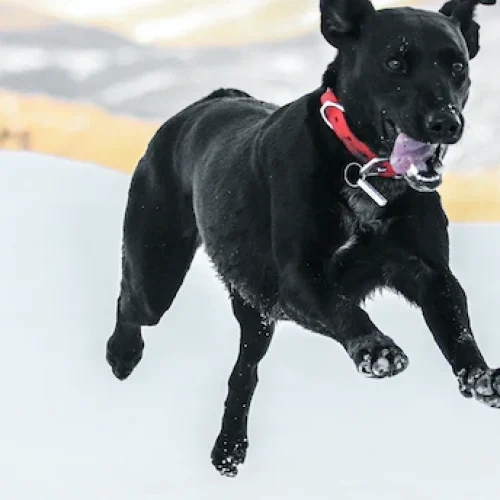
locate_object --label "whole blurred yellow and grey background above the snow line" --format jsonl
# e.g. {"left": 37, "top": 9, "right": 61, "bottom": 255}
{"left": 0, "top": 0, "right": 500, "bottom": 222}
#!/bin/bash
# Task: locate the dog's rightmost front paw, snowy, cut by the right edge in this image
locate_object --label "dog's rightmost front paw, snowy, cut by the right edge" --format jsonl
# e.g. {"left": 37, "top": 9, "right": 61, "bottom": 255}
{"left": 457, "top": 368, "right": 500, "bottom": 408}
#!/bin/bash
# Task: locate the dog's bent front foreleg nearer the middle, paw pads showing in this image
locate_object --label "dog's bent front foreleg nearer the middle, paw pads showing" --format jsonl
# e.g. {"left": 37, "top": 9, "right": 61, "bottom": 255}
{"left": 280, "top": 263, "right": 408, "bottom": 378}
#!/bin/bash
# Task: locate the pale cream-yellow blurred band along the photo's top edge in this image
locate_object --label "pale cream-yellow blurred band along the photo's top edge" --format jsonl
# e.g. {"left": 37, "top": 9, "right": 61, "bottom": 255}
{"left": 0, "top": 0, "right": 428, "bottom": 46}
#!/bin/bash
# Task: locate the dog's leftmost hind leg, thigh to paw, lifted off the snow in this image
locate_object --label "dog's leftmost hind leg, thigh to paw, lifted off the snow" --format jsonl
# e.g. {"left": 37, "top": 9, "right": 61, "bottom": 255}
{"left": 107, "top": 159, "right": 199, "bottom": 380}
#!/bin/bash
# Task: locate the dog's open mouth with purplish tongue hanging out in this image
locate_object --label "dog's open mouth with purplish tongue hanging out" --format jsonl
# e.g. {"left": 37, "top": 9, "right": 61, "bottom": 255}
{"left": 385, "top": 120, "right": 448, "bottom": 192}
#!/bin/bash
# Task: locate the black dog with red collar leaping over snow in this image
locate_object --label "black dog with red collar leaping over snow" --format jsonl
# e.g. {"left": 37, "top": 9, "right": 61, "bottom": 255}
{"left": 107, "top": 0, "right": 500, "bottom": 475}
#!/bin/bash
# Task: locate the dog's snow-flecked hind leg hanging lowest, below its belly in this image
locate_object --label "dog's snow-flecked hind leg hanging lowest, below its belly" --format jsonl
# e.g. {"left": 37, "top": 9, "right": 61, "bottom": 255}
{"left": 212, "top": 295, "right": 275, "bottom": 476}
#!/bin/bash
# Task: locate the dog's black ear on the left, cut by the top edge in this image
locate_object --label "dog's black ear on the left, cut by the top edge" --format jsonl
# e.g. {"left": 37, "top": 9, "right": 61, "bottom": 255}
{"left": 320, "top": 0, "right": 375, "bottom": 48}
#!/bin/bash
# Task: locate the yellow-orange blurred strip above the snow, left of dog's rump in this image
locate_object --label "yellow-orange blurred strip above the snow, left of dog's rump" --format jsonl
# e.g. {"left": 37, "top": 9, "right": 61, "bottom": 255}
{"left": 0, "top": 91, "right": 159, "bottom": 172}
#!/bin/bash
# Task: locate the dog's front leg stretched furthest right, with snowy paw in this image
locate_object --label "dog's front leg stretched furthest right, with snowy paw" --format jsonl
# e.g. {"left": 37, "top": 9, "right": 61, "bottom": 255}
{"left": 419, "top": 270, "right": 500, "bottom": 408}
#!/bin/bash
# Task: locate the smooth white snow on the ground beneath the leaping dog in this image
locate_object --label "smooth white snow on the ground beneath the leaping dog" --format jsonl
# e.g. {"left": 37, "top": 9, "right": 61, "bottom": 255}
{"left": 0, "top": 151, "right": 500, "bottom": 500}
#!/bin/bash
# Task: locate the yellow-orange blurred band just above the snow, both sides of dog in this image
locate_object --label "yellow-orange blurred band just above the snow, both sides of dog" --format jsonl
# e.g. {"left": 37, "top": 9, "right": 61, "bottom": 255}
{"left": 0, "top": 91, "right": 500, "bottom": 222}
